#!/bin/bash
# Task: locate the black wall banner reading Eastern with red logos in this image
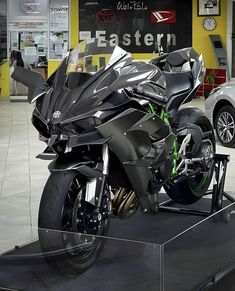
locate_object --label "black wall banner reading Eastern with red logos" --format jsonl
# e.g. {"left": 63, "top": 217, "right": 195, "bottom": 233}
{"left": 79, "top": 0, "right": 192, "bottom": 53}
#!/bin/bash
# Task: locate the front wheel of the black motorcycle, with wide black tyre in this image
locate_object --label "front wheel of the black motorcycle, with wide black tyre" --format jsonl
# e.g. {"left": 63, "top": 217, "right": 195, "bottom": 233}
{"left": 38, "top": 171, "right": 109, "bottom": 276}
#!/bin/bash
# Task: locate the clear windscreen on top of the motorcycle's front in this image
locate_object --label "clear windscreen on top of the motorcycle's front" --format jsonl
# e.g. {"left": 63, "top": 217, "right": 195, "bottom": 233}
{"left": 67, "top": 39, "right": 127, "bottom": 74}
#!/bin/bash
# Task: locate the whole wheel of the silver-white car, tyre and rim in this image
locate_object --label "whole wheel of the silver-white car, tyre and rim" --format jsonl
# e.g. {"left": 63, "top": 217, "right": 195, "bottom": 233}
{"left": 215, "top": 105, "right": 235, "bottom": 147}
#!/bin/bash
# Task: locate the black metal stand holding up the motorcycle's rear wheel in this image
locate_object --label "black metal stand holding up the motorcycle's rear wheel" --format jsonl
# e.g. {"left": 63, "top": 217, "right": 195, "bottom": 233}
{"left": 159, "top": 154, "right": 235, "bottom": 217}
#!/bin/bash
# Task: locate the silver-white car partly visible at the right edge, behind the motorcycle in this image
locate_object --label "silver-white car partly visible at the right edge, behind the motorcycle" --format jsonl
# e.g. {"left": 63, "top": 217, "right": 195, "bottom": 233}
{"left": 205, "top": 82, "right": 235, "bottom": 147}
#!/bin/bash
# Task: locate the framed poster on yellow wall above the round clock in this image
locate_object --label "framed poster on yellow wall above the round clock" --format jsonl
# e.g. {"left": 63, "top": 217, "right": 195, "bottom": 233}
{"left": 197, "top": 0, "right": 220, "bottom": 16}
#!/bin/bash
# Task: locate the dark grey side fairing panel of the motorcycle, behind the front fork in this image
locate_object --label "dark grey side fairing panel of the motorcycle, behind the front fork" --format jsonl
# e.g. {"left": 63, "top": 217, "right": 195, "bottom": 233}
{"left": 97, "top": 109, "right": 169, "bottom": 196}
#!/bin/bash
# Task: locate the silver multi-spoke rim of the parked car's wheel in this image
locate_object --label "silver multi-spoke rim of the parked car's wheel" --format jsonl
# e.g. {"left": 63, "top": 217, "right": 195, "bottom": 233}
{"left": 217, "top": 112, "right": 235, "bottom": 143}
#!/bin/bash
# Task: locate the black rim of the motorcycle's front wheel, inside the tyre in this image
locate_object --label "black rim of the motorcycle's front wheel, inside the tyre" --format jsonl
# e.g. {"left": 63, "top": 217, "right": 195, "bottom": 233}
{"left": 62, "top": 178, "right": 107, "bottom": 262}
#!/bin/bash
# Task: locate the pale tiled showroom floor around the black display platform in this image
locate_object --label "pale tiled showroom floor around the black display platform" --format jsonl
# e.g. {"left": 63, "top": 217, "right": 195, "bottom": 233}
{"left": 0, "top": 98, "right": 235, "bottom": 253}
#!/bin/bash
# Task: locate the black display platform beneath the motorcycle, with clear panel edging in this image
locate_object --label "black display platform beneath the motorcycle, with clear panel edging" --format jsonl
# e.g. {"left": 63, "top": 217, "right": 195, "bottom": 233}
{"left": 0, "top": 199, "right": 235, "bottom": 291}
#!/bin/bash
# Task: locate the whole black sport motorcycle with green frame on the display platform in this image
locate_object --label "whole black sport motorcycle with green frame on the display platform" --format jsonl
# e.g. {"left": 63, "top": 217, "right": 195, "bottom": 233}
{"left": 12, "top": 40, "right": 215, "bottom": 274}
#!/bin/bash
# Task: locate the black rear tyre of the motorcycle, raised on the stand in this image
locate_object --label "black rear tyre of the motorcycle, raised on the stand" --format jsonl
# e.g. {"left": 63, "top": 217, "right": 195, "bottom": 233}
{"left": 164, "top": 109, "right": 215, "bottom": 204}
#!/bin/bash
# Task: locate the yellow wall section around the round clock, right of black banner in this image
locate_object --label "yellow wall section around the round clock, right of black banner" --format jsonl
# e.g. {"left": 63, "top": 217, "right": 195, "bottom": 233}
{"left": 193, "top": 0, "right": 230, "bottom": 68}
